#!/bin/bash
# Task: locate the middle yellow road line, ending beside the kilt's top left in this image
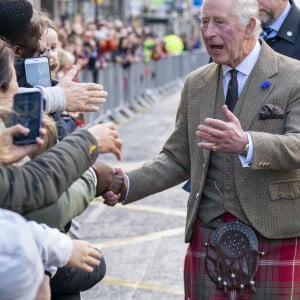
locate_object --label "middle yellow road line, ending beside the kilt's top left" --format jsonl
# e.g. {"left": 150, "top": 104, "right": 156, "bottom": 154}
{"left": 93, "top": 227, "right": 184, "bottom": 249}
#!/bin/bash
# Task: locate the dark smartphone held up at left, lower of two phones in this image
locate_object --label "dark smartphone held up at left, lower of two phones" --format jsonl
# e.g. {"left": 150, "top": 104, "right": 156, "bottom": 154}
{"left": 12, "top": 91, "right": 43, "bottom": 145}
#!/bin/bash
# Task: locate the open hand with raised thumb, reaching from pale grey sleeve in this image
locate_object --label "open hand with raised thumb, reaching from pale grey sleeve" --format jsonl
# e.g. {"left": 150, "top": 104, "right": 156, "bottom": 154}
{"left": 58, "top": 65, "right": 107, "bottom": 112}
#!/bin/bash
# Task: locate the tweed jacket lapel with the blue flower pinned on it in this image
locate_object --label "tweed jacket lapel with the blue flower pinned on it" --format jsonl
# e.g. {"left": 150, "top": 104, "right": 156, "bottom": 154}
{"left": 234, "top": 41, "right": 278, "bottom": 131}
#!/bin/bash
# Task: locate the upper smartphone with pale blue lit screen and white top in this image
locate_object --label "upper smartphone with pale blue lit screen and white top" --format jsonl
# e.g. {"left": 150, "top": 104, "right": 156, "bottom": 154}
{"left": 24, "top": 56, "right": 51, "bottom": 87}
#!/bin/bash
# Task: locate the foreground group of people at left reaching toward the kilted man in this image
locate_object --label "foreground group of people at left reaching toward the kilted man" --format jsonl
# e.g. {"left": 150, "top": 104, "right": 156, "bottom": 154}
{"left": 0, "top": 0, "right": 122, "bottom": 300}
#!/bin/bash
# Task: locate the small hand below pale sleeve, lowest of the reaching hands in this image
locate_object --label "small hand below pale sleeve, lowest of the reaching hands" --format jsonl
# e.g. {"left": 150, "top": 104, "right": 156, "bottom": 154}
{"left": 67, "top": 240, "right": 102, "bottom": 272}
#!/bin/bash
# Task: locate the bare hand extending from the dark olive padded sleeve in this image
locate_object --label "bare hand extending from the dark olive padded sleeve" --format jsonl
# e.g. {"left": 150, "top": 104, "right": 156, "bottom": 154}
{"left": 88, "top": 123, "right": 122, "bottom": 160}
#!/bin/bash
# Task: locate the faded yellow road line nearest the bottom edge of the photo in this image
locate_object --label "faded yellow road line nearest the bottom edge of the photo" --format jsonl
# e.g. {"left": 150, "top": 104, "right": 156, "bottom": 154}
{"left": 101, "top": 277, "right": 184, "bottom": 296}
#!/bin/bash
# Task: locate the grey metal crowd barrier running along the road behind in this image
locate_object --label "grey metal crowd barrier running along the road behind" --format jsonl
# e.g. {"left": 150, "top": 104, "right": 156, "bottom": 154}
{"left": 78, "top": 50, "right": 209, "bottom": 127}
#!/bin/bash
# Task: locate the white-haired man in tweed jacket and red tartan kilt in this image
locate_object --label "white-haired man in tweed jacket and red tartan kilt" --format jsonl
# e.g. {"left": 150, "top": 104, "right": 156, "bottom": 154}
{"left": 105, "top": 0, "right": 300, "bottom": 300}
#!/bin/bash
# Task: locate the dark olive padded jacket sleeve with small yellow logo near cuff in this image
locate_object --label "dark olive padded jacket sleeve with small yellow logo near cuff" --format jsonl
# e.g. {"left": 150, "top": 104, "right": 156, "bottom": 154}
{"left": 0, "top": 130, "right": 98, "bottom": 214}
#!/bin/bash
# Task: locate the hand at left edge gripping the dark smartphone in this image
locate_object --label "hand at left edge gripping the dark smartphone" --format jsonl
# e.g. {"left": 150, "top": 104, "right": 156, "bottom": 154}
{"left": 0, "top": 124, "right": 46, "bottom": 164}
